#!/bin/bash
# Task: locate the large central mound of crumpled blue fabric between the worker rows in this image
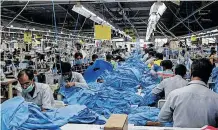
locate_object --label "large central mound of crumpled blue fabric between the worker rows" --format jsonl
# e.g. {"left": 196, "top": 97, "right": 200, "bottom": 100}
{"left": 60, "top": 53, "right": 159, "bottom": 125}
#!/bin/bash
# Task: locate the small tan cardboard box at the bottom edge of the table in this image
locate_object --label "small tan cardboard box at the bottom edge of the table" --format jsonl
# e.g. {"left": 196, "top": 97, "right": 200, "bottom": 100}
{"left": 104, "top": 114, "right": 128, "bottom": 130}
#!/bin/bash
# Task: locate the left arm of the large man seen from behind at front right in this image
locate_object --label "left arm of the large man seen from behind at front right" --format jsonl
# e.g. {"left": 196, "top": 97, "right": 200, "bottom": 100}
{"left": 158, "top": 93, "right": 174, "bottom": 122}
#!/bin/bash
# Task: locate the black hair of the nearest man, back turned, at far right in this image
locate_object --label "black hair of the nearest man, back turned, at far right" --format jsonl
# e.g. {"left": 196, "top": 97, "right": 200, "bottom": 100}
{"left": 191, "top": 58, "right": 213, "bottom": 83}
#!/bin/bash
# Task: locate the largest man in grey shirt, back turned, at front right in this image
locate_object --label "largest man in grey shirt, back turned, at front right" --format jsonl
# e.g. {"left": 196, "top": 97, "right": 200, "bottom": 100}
{"left": 158, "top": 58, "right": 218, "bottom": 128}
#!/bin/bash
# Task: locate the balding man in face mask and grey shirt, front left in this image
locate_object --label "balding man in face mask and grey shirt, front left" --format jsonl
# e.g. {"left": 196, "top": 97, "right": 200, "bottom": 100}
{"left": 17, "top": 69, "right": 54, "bottom": 111}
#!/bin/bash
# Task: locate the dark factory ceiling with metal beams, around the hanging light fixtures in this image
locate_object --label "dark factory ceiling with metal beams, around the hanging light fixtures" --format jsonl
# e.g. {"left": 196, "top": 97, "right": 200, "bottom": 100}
{"left": 1, "top": 0, "right": 218, "bottom": 38}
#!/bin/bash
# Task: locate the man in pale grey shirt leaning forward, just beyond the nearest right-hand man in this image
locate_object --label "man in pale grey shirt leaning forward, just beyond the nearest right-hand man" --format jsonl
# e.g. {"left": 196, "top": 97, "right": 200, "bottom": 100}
{"left": 152, "top": 64, "right": 188, "bottom": 99}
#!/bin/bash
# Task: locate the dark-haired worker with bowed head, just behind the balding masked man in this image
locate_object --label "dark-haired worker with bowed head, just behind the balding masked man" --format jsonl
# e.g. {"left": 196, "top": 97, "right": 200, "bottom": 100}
{"left": 60, "top": 62, "right": 88, "bottom": 88}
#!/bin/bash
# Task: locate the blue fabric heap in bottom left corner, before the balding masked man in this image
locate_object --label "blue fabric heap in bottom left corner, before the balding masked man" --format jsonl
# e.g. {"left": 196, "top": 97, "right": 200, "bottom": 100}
{"left": 1, "top": 97, "right": 106, "bottom": 130}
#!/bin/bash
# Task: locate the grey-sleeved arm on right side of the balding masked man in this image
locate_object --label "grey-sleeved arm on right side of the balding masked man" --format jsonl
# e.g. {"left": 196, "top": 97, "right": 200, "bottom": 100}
{"left": 42, "top": 85, "right": 54, "bottom": 111}
